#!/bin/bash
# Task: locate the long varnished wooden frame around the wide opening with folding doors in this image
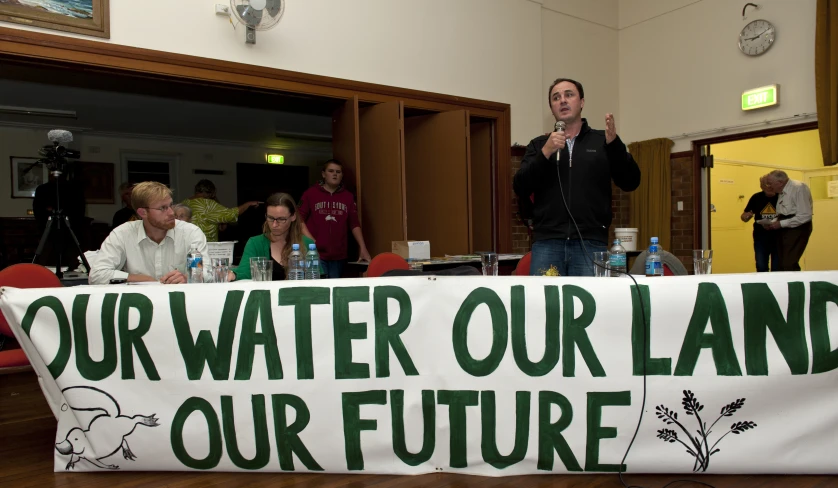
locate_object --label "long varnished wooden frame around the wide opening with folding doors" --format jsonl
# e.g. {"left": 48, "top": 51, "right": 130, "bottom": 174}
{"left": 0, "top": 27, "right": 512, "bottom": 252}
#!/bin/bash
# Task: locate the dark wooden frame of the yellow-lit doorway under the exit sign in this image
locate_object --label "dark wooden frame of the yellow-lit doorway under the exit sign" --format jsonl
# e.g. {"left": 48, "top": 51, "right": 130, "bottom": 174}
{"left": 692, "top": 120, "right": 818, "bottom": 249}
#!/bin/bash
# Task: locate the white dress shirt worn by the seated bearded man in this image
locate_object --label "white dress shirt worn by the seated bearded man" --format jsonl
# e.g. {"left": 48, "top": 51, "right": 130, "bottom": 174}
{"left": 88, "top": 220, "right": 209, "bottom": 285}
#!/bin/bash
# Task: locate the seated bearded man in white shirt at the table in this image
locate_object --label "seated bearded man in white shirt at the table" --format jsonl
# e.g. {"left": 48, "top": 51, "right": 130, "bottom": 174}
{"left": 89, "top": 181, "right": 207, "bottom": 285}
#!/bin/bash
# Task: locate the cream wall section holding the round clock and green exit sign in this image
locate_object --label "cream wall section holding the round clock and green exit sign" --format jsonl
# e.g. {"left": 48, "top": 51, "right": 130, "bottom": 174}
{"left": 619, "top": 0, "right": 816, "bottom": 151}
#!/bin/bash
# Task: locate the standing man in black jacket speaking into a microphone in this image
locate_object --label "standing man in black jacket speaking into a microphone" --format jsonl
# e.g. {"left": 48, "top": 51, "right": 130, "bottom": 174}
{"left": 513, "top": 78, "right": 640, "bottom": 276}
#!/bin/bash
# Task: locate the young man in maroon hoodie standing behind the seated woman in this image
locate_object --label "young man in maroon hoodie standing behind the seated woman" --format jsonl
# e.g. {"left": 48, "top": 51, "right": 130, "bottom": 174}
{"left": 300, "top": 159, "right": 371, "bottom": 278}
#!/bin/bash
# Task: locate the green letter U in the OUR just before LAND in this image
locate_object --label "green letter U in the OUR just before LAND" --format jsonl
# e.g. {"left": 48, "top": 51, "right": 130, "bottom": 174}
{"left": 511, "top": 285, "right": 561, "bottom": 376}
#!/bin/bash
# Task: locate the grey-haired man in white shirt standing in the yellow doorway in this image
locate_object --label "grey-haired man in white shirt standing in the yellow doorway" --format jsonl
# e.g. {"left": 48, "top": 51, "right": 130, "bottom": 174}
{"left": 763, "top": 170, "right": 812, "bottom": 271}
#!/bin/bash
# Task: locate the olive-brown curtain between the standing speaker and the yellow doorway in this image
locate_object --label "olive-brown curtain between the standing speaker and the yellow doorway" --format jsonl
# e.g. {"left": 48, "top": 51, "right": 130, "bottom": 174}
{"left": 629, "top": 139, "right": 674, "bottom": 252}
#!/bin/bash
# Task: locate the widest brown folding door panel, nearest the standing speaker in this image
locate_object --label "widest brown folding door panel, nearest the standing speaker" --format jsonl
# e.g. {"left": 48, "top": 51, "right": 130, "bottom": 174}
{"left": 404, "top": 110, "right": 472, "bottom": 256}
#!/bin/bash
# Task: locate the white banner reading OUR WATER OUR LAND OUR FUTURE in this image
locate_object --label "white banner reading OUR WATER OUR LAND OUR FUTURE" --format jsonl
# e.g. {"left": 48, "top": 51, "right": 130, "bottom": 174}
{"left": 0, "top": 272, "right": 838, "bottom": 476}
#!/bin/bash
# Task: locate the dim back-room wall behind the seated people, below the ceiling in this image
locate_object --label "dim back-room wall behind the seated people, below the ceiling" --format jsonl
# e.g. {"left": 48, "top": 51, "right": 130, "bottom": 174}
{"left": 0, "top": 127, "right": 331, "bottom": 222}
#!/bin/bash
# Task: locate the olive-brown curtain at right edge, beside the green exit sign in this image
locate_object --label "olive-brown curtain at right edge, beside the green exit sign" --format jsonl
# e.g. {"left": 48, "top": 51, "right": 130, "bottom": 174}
{"left": 815, "top": 0, "right": 838, "bottom": 166}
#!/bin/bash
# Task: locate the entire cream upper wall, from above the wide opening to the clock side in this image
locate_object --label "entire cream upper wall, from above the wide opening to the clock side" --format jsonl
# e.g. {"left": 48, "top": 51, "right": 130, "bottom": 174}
{"left": 3, "top": 0, "right": 815, "bottom": 156}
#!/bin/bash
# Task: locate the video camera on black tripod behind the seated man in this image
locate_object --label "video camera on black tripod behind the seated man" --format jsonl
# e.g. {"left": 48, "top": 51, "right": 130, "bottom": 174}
{"left": 32, "top": 129, "right": 90, "bottom": 278}
